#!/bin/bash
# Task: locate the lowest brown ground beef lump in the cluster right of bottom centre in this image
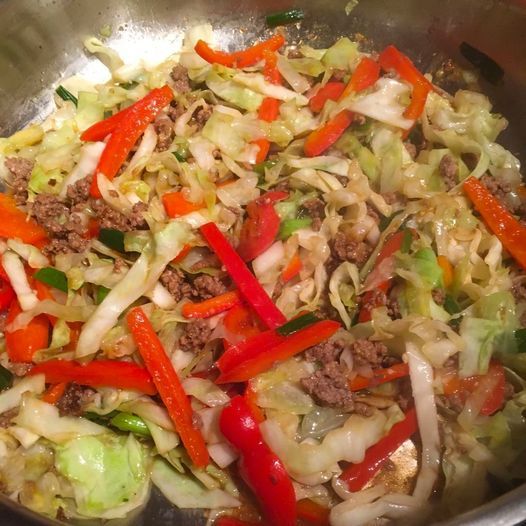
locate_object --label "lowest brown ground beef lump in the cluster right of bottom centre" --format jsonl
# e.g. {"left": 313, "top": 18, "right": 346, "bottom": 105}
{"left": 301, "top": 362, "right": 354, "bottom": 411}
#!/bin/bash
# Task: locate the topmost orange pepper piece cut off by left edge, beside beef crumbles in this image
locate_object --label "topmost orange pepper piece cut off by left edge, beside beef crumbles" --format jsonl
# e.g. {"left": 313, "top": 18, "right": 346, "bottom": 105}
{"left": 0, "top": 193, "right": 48, "bottom": 245}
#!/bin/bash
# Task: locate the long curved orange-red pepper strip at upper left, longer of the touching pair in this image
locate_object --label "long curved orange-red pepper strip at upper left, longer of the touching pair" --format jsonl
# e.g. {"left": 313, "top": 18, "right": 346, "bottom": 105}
{"left": 90, "top": 86, "right": 173, "bottom": 197}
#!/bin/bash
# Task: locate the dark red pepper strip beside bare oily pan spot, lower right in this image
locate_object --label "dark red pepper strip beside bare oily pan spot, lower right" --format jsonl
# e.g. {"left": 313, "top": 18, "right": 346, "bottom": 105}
{"left": 340, "top": 408, "right": 418, "bottom": 491}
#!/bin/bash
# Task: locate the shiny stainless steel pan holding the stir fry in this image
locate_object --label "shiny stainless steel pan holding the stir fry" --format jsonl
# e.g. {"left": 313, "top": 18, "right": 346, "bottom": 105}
{"left": 0, "top": 0, "right": 526, "bottom": 526}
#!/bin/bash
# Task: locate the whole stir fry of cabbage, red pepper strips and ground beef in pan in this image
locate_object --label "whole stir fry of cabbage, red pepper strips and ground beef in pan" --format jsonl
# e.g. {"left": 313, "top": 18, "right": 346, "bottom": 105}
{"left": 0, "top": 19, "right": 526, "bottom": 526}
